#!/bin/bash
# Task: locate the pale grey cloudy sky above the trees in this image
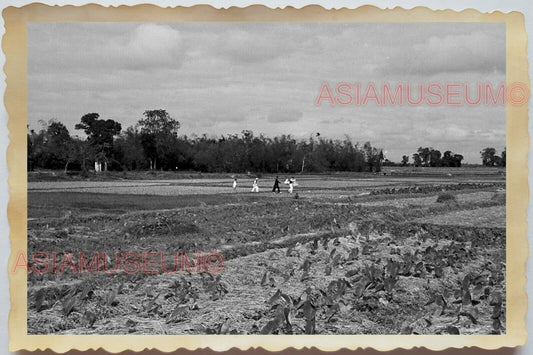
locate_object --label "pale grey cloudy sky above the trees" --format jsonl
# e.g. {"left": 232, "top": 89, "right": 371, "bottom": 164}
{"left": 28, "top": 23, "right": 505, "bottom": 163}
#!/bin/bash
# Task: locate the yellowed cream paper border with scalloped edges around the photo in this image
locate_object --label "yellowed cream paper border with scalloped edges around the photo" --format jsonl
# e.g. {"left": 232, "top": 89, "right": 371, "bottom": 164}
{"left": 2, "top": 4, "right": 530, "bottom": 352}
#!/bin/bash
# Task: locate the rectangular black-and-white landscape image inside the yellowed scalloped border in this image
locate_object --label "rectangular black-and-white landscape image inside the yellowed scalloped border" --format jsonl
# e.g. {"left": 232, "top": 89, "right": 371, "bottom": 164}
{"left": 26, "top": 22, "right": 508, "bottom": 335}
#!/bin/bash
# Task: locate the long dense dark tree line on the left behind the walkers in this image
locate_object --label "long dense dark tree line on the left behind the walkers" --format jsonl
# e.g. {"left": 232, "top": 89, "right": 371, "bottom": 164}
{"left": 28, "top": 110, "right": 384, "bottom": 173}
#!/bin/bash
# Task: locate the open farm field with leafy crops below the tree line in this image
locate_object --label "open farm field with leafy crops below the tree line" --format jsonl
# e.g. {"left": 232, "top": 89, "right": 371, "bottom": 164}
{"left": 28, "top": 169, "right": 506, "bottom": 334}
